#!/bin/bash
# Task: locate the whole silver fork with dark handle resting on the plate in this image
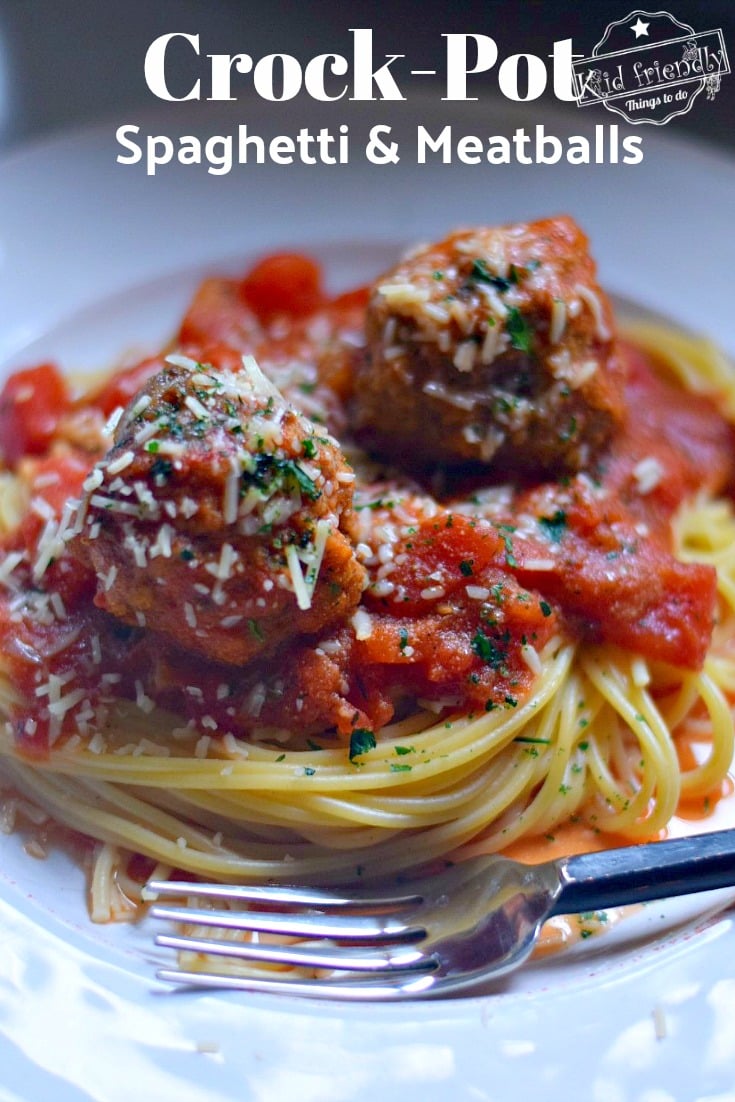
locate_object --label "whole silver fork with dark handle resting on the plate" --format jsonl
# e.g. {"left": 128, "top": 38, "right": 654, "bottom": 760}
{"left": 147, "top": 830, "right": 735, "bottom": 1002}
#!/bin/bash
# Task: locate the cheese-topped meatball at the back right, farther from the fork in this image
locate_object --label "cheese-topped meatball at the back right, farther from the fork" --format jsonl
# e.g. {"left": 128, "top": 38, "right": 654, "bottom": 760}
{"left": 354, "top": 217, "right": 624, "bottom": 472}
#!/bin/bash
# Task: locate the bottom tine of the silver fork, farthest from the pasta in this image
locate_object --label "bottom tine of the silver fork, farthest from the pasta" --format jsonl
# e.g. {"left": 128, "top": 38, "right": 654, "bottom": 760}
{"left": 156, "top": 969, "right": 434, "bottom": 1003}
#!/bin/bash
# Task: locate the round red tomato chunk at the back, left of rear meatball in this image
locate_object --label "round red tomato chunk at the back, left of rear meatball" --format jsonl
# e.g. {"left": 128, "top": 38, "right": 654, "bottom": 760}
{"left": 238, "top": 252, "right": 325, "bottom": 323}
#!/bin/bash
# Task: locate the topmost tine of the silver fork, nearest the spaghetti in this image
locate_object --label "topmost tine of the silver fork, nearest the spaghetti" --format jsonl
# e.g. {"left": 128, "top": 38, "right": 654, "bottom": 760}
{"left": 145, "top": 880, "right": 422, "bottom": 912}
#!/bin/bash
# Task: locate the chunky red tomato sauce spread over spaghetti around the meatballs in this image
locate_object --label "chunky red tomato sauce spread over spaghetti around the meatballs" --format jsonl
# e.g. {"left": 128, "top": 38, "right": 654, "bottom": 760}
{"left": 0, "top": 256, "right": 735, "bottom": 758}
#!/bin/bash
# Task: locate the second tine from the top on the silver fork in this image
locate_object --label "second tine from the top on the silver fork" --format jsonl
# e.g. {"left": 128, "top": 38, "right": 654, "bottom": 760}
{"left": 150, "top": 906, "right": 425, "bottom": 943}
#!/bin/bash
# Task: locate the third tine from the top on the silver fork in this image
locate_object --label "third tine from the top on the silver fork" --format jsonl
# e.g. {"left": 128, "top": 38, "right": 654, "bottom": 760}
{"left": 155, "top": 933, "right": 434, "bottom": 975}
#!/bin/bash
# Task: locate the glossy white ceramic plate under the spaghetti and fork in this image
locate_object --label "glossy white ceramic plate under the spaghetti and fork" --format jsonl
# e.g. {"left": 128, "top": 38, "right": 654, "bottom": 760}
{"left": 0, "top": 101, "right": 735, "bottom": 1102}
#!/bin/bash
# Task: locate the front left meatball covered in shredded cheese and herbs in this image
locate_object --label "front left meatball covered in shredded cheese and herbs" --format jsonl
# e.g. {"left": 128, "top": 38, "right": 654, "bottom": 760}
{"left": 73, "top": 350, "right": 365, "bottom": 665}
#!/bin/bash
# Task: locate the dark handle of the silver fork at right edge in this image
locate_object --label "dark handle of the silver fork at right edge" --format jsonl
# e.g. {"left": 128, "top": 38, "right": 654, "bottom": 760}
{"left": 551, "top": 830, "right": 735, "bottom": 915}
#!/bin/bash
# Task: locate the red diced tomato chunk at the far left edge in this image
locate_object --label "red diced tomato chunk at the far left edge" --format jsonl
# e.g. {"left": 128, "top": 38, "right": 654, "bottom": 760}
{"left": 0, "top": 364, "right": 71, "bottom": 466}
